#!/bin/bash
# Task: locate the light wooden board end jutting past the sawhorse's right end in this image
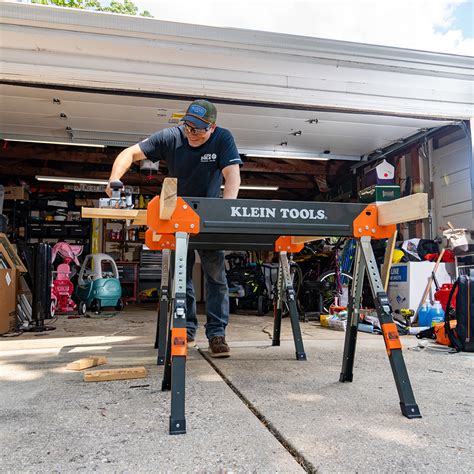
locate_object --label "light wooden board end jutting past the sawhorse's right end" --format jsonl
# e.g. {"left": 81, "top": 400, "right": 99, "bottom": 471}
{"left": 377, "top": 193, "right": 428, "bottom": 225}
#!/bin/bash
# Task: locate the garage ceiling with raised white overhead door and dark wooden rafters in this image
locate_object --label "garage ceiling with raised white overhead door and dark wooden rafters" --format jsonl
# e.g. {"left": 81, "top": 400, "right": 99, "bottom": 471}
{"left": 0, "top": 84, "right": 451, "bottom": 199}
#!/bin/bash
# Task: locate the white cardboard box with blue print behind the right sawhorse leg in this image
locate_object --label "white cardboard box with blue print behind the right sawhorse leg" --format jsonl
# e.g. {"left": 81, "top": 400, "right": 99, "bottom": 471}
{"left": 387, "top": 262, "right": 455, "bottom": 311}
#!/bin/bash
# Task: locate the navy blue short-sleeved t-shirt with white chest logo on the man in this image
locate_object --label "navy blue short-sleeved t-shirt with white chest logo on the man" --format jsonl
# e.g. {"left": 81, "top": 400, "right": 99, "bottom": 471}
{"left": 139, "top": 126, "right": 243, "bottom": 197}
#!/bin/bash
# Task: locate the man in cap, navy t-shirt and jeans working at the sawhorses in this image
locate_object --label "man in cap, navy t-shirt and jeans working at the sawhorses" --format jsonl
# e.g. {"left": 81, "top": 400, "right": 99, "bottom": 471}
{"left": 106, "top": 100, "right": 242, "bottom": 357}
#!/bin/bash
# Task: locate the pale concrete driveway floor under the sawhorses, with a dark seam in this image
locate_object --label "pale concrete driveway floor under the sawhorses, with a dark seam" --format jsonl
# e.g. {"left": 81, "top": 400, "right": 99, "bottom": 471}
{"left": 0, "top": 305, "right": 474, "bottom": 472}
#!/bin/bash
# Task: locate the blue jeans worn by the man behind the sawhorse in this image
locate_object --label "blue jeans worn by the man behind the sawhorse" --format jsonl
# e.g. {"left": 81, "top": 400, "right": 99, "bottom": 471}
{"left": 186, "top": 250, "right": 229, "bottom": 339}
